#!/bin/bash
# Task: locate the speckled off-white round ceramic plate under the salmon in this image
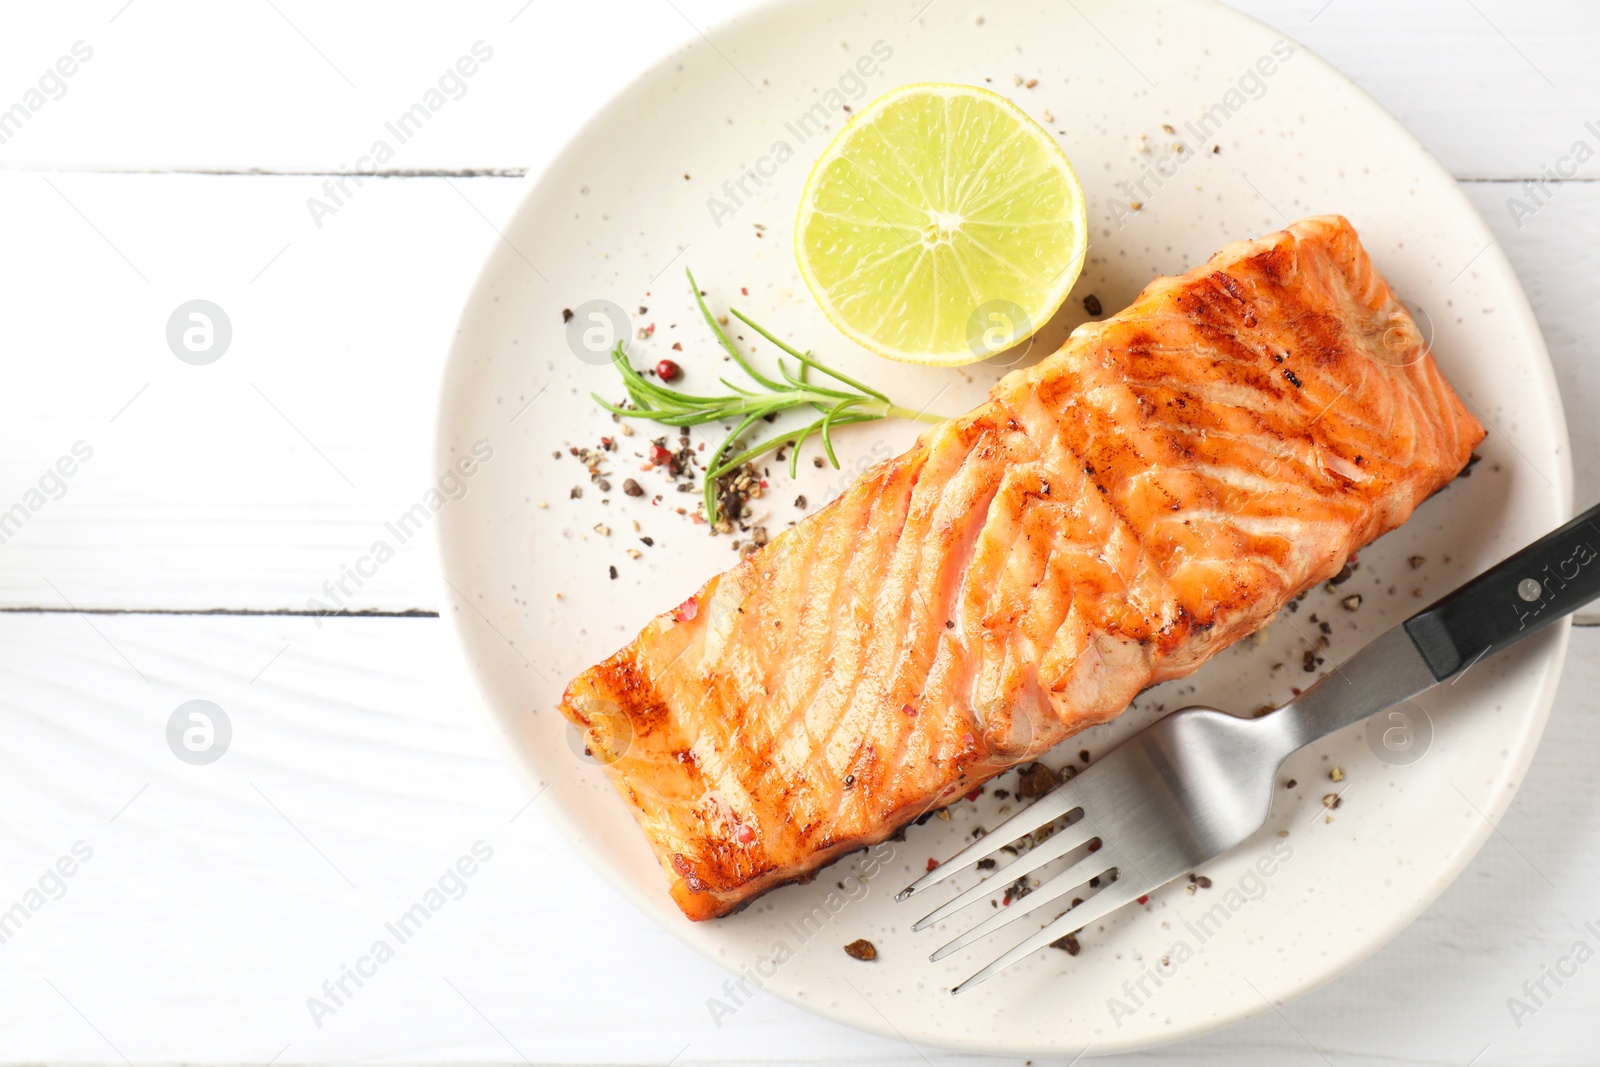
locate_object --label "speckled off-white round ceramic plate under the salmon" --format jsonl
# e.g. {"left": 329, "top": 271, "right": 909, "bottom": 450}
{"left": 437, "top": 0, "right": 1570, "bottom": 1056}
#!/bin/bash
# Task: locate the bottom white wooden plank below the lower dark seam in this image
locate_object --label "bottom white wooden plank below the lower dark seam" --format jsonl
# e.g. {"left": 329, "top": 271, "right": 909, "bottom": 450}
{"left": 0, "top": 614, "right": 1600, "bottom": 1067}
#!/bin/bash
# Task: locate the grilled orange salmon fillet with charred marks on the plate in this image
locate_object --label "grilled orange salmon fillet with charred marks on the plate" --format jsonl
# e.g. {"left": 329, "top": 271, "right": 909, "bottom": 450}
{"left": 562, "top": 216, "right": 1483, "bottom": 920}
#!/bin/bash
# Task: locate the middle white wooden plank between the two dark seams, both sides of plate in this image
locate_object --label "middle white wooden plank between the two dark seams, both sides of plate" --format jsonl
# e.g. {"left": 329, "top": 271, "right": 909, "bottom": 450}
{"left": 0, "top": 174, "right": 1600, "bottom": 611}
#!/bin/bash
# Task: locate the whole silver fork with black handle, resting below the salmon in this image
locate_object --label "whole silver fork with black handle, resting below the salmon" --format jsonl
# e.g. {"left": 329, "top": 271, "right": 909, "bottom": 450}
{"left": 896, "top": 506, "right": 1600, "bottom": 993}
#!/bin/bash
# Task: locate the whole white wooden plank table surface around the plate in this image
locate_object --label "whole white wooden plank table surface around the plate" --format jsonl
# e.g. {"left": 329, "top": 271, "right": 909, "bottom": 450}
{"left": 0, "top": 0, "right": 1600, "bottom": 1064}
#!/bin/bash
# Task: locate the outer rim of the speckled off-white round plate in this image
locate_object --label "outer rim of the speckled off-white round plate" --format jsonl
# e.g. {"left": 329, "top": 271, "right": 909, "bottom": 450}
{"left": 434, "top": 0, "right": 1573, "bottom": 1057}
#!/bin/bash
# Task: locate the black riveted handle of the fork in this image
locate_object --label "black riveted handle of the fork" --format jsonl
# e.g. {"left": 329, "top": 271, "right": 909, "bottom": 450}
{"left": 1405, "top": 506, "right": 1600, "bottom": 681}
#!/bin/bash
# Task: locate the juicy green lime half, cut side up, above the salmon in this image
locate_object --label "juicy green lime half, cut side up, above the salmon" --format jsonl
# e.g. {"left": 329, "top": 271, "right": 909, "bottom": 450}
{"left": 795, "top": 83, "right": 1088, "bottom": 366}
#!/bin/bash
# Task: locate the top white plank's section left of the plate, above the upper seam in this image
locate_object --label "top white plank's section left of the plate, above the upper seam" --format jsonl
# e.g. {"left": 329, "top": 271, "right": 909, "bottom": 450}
{"left": 0, "top": 0, "right": 742, "bottom": 173}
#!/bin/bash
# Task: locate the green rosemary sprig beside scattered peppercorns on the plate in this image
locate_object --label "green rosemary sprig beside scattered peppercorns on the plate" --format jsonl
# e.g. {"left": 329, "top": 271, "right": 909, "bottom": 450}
{"left": 590, "top": 270, "right": 944, "bottom": 530}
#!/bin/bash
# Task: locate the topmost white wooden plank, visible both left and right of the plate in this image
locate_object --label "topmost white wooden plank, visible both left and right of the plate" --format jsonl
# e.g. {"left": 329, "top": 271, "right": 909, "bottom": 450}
{"left": 0, "top": 0, "right": 1600, "bottom": 178}
